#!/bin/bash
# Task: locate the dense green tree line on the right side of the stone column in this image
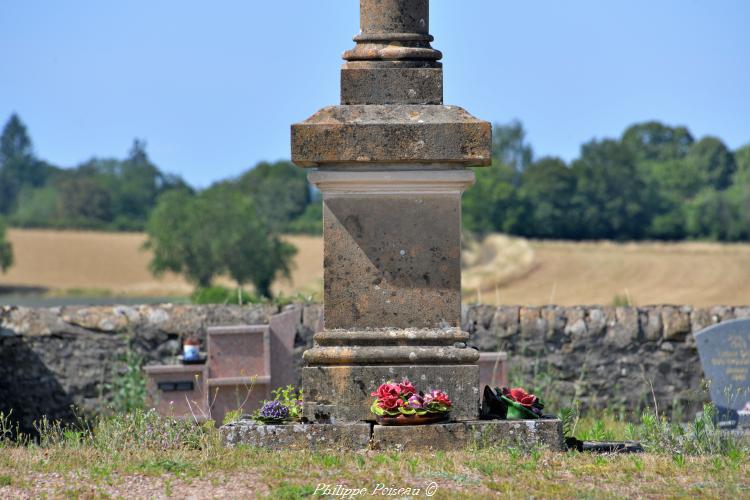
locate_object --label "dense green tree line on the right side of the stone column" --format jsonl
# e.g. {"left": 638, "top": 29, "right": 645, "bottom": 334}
{"left": 463, "top": 121, "right": 750, "bottom": 241}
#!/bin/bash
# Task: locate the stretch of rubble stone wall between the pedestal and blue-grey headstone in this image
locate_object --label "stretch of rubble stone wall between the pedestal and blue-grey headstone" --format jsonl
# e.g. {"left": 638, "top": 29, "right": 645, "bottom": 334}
{"left": 463, "top": 305, "right": 750, "bottom": 414}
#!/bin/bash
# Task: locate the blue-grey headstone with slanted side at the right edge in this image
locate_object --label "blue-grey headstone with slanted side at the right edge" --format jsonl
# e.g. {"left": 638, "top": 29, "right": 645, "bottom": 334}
{"left": 695, "top": 319, "right": 750, "bottom": 427}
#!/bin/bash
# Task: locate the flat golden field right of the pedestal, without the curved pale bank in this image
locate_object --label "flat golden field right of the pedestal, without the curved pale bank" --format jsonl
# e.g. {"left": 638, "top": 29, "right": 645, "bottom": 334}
{"left": 464, "top": 236, "right": 750, "bottom": 307}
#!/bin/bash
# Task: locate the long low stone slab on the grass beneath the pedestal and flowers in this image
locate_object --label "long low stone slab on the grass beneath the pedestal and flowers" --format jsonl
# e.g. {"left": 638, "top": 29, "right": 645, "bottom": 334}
{"left": 220, "top": 420, "right": 565, "bottom": 451}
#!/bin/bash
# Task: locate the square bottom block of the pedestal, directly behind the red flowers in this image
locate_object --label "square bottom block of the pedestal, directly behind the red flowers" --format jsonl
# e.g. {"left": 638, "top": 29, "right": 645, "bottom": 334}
{"left": 302, "top": 365, "right": 480, "bottom": 423}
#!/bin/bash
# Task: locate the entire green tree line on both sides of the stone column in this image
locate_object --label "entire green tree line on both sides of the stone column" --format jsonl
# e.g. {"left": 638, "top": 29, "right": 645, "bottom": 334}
{"left": 0, "top": 114, "right": 750, "bottom": 295}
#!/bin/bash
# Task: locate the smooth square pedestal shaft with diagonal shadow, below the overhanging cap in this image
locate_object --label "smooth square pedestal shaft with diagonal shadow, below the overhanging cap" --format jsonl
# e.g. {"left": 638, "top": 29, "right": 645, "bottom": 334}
{"left": 309, "top": 170, "right": 474, "bottom": 330}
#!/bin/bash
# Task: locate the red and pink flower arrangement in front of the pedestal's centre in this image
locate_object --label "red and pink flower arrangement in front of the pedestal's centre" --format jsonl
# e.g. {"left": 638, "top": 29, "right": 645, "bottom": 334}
{"left": 370, "top": 379, "right": 453, "bottom": 425}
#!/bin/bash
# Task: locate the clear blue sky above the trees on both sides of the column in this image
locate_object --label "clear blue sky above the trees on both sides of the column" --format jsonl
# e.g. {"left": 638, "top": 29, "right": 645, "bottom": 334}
{"left": 0, "top": 0, "right": 750, "bottom": 186}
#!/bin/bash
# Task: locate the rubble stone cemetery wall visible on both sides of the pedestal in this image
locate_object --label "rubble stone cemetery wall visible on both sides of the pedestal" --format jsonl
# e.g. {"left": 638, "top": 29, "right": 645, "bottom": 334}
{"left": 0, "top": 305, "right": 750, "bottom": 428}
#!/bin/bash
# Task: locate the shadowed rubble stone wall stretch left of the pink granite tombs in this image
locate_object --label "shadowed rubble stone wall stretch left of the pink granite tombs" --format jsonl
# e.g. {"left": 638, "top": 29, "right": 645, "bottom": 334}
{"left": 0, "top": 305, "right": 284, "bottom": 431}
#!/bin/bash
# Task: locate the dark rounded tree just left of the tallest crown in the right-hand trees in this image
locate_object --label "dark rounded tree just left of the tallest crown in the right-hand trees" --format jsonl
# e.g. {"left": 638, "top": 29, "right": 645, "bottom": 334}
{"left": 572, "top": 139, "right": 648, "bottom": 240}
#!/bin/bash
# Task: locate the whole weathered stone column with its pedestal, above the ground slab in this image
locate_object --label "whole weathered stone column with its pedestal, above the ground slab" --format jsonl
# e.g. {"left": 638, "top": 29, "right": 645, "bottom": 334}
{"left": 292, "top": 0, "right": 491, "bottom": 421}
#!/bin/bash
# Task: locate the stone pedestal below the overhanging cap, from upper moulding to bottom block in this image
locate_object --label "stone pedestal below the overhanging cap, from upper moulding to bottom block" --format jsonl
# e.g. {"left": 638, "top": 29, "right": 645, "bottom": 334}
{"left": 302, "top": 169, "right": 479, "bottom": 421}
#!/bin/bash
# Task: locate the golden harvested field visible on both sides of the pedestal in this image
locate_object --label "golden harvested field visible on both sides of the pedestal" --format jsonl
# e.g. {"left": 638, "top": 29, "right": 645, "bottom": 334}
{"left": 0, "top": 229, "right": 750, "bottom": 307}
